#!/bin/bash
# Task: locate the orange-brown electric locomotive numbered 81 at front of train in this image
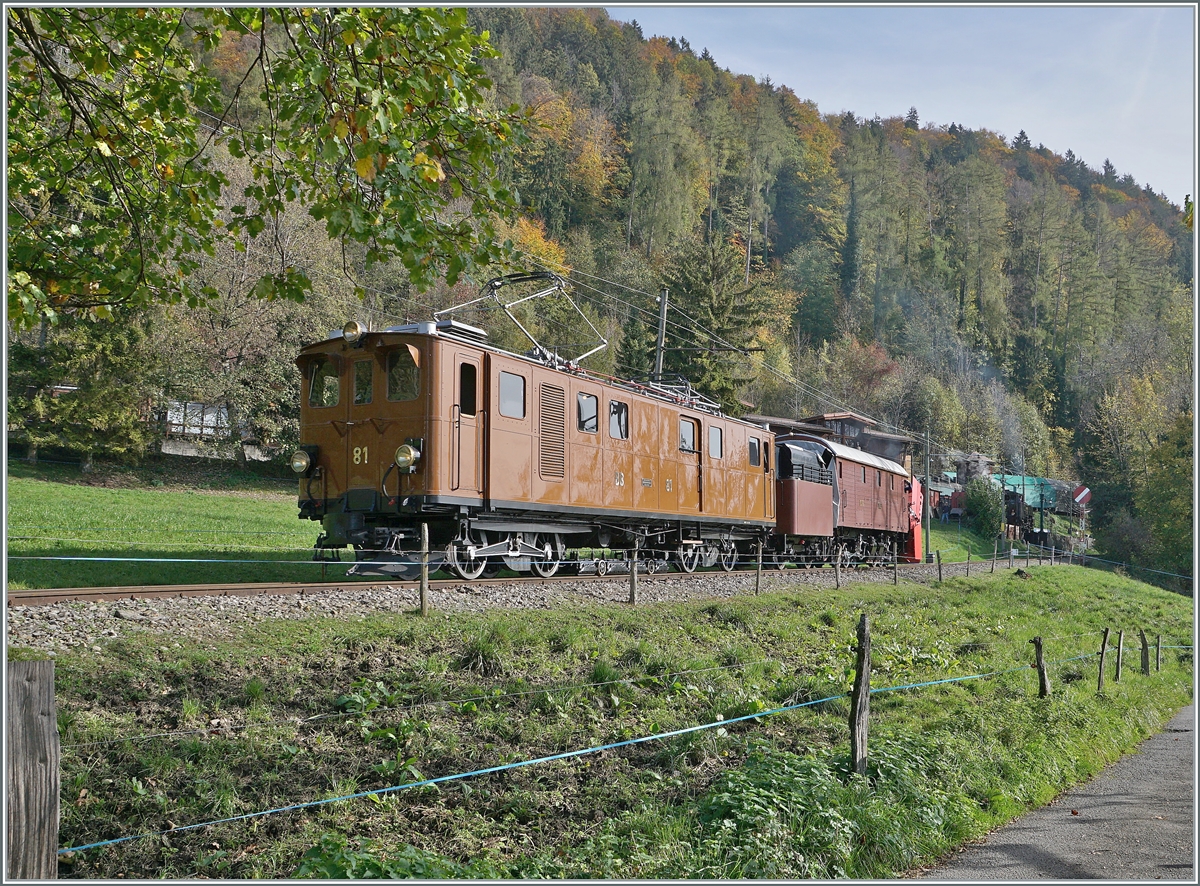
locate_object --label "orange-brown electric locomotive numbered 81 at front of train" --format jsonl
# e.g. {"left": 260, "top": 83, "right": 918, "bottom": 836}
{"left": 292, "top": 277, "right": 775, "bottom": 579}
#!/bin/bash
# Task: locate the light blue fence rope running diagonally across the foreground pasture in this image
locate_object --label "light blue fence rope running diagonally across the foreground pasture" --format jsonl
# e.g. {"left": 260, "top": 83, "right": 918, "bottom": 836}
{"left": 58, "top": 652, "right": 1098, "bottom": 855}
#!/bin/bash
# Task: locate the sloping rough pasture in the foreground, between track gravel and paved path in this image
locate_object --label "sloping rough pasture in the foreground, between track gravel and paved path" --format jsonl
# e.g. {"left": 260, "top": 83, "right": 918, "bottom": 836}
{"left": 10, "top": 565, "right": 1193, "bottom": 879}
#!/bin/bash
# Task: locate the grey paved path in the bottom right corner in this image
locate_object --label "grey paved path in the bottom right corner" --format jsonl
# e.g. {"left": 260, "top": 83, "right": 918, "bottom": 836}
{"left": 922, "top": 705, "right": 1196, "bottom": 882}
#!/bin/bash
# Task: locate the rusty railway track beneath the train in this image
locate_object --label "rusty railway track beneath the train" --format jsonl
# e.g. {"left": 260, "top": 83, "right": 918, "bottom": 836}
{"left": 7, "top": 563, "right": 929, "bottom": 606}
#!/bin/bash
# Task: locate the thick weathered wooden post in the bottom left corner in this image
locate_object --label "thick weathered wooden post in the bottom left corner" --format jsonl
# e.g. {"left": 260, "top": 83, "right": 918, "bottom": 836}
{"left": 5, "top": 661, "right": 59, "bottom": 880}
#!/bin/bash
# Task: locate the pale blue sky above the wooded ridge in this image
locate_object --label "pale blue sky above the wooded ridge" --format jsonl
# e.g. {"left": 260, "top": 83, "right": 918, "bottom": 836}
{"left": 605, "top": 4, "right": 1196, "bottom": 206}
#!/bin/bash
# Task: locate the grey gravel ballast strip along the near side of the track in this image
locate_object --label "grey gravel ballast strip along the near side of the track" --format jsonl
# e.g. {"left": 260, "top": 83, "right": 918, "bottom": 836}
{"left": 6, "top": 563, "right": 979, "bottom": 654}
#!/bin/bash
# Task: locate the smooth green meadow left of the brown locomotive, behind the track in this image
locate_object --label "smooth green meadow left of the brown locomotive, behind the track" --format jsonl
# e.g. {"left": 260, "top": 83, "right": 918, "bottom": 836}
{"left": 7, "top": 466, "right": 349, "bottom": 589}
